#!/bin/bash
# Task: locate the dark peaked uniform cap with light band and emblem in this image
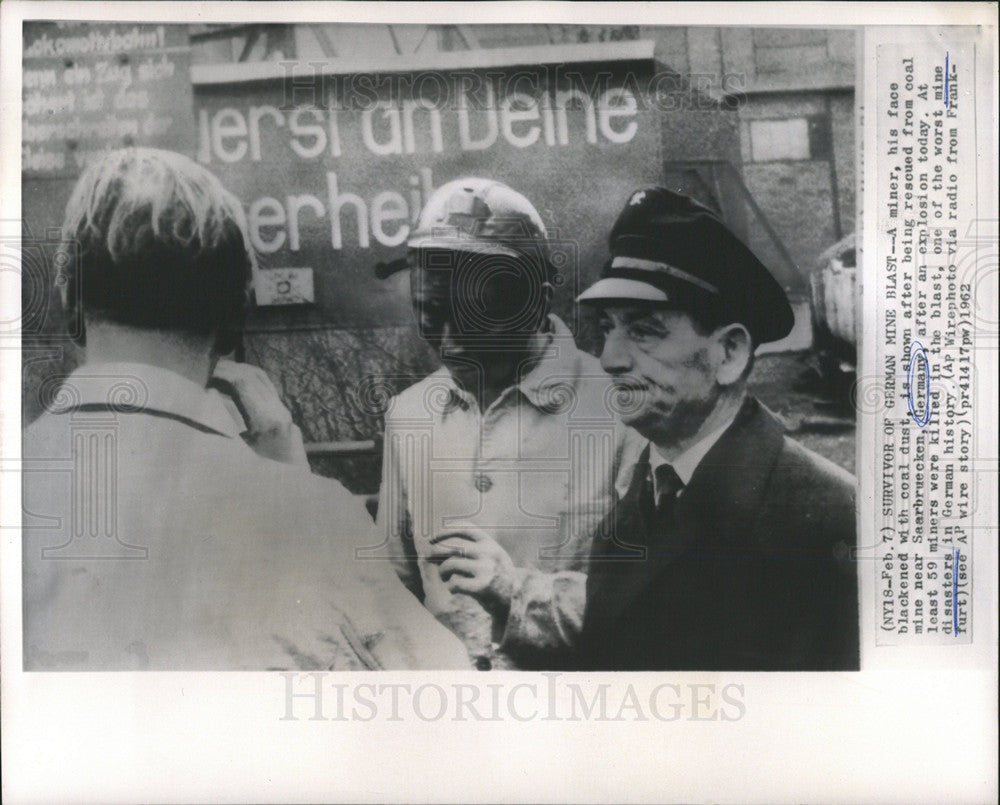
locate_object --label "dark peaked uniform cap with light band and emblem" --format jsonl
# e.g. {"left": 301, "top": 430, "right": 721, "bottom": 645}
{"left": 577, "top": 187, "right": 794, "bottom": 344}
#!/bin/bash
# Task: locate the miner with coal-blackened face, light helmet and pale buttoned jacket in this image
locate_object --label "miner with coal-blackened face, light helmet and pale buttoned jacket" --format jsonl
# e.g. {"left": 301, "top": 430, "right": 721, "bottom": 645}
{"left": 378, "top": 178, "right": 640, "bottom": 669}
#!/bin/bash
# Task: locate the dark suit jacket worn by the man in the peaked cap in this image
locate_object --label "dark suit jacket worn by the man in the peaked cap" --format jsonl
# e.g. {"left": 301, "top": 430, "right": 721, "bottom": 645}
{"left": 578, "top": 398, "right": 859, "bottom": 671}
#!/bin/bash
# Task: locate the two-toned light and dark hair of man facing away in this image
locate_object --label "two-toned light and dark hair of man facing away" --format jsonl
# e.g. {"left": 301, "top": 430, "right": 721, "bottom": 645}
{"left": 62, "top": 148, "right": 254, "bottom": 335}
